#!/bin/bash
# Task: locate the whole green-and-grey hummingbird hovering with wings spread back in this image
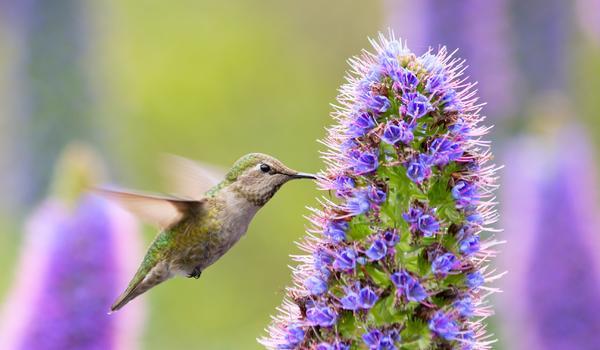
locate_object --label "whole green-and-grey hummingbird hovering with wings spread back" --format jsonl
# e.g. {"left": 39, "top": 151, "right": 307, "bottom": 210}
{"left": 97, "top": 153, "right": 317, "bottom": 312}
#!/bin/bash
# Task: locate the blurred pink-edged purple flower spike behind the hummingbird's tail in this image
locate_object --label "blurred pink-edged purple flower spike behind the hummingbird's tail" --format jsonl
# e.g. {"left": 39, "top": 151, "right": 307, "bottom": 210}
{"left": 0, "top": 144, "right": 143, "bottom": 349}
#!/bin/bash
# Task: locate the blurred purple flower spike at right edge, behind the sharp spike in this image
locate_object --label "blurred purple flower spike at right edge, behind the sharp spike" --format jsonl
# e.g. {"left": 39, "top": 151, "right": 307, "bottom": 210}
{"left": 498, "top": 119, "right": 600, "bottom": 350}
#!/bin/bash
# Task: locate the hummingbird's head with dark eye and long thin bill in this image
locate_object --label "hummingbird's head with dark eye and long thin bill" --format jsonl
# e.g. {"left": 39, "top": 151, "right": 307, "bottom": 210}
{"left": 226, "top": 153, "right": 317, "bottom": 206}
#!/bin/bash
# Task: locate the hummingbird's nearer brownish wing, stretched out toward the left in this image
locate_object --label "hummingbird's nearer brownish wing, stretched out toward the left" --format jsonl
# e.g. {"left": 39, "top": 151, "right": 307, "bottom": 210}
{"left": 95, "top": 188, "right": 203, "bottom": 229}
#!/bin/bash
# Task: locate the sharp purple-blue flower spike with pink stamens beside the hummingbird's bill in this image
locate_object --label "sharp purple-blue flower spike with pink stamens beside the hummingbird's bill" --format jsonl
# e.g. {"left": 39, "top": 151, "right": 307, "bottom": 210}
{"left": 260, "top": 34, "right": 496, "bottom": 349}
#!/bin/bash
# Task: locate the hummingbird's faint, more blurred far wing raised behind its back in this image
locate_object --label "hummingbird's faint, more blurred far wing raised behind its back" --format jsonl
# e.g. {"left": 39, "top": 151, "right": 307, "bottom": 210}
{"left": 161, "top": 154, "right": 226, "bottom": 199}
